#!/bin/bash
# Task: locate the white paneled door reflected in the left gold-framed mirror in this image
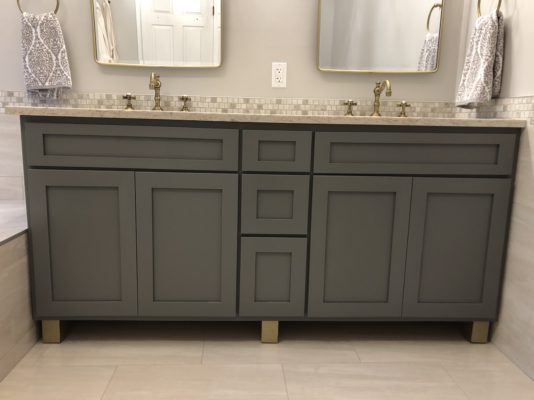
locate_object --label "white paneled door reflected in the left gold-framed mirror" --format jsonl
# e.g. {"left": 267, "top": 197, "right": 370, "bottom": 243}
{"left": 136, "top": 0, "right": 221, "bottom": 66}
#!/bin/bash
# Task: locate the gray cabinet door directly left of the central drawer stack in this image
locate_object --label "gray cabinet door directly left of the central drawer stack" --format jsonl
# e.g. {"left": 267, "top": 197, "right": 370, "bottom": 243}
{"left": 136, "top": 172, "right": 238, "bottom": 318}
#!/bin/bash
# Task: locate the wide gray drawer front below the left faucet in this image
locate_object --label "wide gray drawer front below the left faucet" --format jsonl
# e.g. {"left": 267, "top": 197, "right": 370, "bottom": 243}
{"left": 23, "top": 122, "right": 239, "bottom": 171}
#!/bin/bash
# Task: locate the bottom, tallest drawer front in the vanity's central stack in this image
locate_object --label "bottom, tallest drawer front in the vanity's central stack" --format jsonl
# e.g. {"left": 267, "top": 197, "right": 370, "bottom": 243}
{"left": 239, "top": 237, "right": 307, "bottom": 318}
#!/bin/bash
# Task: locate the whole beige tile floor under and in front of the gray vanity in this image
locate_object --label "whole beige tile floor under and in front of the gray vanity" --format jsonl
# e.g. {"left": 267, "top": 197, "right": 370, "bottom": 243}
{"left": 0, "top": 323, "right": 534, "bottom": 400}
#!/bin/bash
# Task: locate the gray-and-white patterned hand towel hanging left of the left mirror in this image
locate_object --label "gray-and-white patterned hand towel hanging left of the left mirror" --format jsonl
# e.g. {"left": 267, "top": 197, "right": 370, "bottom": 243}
{"left": 22, "top": 13, "right": 72, "bottom": 98}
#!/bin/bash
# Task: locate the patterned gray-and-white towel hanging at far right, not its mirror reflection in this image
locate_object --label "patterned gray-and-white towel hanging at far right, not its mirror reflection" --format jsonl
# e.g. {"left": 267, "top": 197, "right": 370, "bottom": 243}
{"left": 456, "top": 11, "right": 504, "bottom": 108}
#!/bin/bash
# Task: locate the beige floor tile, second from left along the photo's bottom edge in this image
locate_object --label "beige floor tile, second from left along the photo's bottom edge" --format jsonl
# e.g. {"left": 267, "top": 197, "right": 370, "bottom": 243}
{"left": 103, "top": 365, "right": 287, "bottom": 400}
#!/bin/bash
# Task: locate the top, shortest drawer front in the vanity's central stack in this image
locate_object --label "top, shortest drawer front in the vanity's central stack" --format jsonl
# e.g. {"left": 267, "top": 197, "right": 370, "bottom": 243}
{"left": 243, "top": 130, "right": 312, "bottom": 172}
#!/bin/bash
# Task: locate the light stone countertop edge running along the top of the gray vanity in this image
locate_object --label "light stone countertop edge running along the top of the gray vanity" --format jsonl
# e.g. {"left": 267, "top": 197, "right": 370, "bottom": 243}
{"left": 6, "top": 106, "right": 527, "bottom": 128}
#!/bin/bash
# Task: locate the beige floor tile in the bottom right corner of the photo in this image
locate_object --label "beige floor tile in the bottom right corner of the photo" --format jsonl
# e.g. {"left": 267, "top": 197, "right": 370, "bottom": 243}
{"left": 446, "top": 363, "right": 534, "bottom": 400}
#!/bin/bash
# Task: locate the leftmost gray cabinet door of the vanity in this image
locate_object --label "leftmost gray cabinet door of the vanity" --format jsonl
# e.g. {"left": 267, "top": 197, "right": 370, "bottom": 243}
{"left": 27, "top": 170, "right": 137, "bottom": 319}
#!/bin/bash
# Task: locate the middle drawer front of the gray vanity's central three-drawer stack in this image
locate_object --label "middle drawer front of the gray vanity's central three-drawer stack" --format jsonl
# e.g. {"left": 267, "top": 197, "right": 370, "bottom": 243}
{"left": 241, "top": 175, "right": 310, "bottom": 235}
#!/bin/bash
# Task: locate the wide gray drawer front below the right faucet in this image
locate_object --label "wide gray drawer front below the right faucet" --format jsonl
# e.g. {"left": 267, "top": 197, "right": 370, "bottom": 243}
{"left": 315, "top": 132, "right": 515, "bottom": 175}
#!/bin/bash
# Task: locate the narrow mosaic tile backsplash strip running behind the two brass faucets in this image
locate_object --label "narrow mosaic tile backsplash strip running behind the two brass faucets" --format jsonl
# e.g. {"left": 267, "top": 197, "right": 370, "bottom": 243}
{"left": 0, "top": 91, "right": 534, "bottom": 124}
